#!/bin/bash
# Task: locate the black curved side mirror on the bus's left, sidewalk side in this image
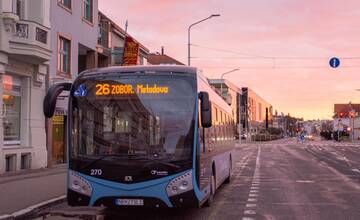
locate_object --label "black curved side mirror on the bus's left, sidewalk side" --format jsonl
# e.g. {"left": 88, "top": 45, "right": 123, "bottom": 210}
{"left": 43, "top": 83, "right": 72, "bottom": 118}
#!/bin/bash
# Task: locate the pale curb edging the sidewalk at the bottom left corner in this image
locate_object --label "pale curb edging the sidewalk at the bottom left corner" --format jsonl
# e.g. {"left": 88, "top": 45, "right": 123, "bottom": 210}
{"left": 0, "top": 195, "right": 66, "bottom": 220}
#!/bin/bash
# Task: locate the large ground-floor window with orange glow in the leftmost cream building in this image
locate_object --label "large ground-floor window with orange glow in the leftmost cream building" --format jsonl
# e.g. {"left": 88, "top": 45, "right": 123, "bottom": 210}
{"left": 2, "top": 75, "right": 21, "bottom": 145}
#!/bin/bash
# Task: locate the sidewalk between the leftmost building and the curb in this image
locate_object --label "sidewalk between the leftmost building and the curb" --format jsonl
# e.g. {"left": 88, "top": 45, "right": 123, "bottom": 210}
{"left": 0, "top": 164, "right": 67, "bottom": 219}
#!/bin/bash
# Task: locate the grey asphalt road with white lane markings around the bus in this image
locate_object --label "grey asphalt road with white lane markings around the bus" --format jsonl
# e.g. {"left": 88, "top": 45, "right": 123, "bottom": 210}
{"left": 34, "top": 139, "right": 360, "bottom": 220}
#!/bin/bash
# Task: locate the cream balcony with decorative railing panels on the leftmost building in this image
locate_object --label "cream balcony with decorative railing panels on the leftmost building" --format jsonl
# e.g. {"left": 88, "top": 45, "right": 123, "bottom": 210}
{"left": 9, "top": 20, "right": 51, "bottom": 64}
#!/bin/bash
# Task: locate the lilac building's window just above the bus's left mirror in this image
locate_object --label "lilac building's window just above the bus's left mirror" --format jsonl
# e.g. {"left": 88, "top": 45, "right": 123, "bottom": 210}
{"left": 58, "top": 36, "right": 71, "bottom": 74}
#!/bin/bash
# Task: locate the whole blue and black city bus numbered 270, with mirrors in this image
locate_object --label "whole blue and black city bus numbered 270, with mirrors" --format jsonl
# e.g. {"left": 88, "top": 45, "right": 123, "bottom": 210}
{"left": 43, "top": 66, "right": 235, "bottom": 207}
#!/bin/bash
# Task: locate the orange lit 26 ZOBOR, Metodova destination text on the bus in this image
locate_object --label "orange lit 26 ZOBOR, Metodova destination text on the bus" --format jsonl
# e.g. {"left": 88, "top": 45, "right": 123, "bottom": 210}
{"left": 95, "top": 83, "right": 169, "bottom": 96}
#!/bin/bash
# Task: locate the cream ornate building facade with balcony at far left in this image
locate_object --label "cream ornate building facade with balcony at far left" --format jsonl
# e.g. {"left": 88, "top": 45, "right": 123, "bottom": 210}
{"left": 0, "top": 0, "right": 52, "bottom": 174}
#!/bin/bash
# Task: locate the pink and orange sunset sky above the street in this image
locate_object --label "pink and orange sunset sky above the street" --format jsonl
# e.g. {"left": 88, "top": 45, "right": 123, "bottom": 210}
{"left": 99, "top": 0, "right": 360, "bottom": 119}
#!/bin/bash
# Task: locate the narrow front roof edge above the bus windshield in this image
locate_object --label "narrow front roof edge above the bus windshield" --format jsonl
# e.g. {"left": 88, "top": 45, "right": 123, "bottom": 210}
{"left": 79, "top": 65, "right": 197, "bottom": 76}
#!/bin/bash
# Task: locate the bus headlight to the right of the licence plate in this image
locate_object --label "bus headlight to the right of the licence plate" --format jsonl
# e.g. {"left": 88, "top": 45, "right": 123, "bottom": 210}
{"left": 166, "top": 171, "right": 193, "bottom": 197}
